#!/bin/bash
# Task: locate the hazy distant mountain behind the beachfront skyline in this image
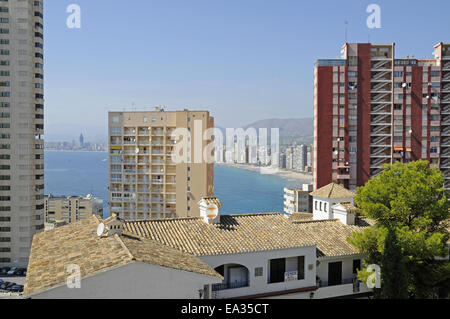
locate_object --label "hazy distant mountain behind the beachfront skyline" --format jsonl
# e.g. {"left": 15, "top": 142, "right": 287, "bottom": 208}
{"left": 217, "top": 118, "right": 314, "bottom": 145}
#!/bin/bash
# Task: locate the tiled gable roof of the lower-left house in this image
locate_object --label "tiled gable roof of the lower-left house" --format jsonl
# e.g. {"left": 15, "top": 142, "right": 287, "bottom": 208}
{"left": 24, "top": 216, "right": 221, "bottom": 295}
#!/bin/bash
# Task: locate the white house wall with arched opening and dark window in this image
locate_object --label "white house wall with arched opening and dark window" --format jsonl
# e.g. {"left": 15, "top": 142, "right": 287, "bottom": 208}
{"left": 201, "top": 246, "right": 317, "bottom": 298}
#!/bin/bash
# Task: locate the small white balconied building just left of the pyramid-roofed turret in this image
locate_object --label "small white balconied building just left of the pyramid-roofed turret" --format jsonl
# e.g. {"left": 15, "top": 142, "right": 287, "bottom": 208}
{"left": 284, "top": 184, "right": 313, "bottom": 216}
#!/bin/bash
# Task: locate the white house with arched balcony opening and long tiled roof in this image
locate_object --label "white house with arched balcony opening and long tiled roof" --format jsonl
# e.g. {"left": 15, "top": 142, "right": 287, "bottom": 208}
{"left": 121, "top": 199, "right": 370, "bottom": 299}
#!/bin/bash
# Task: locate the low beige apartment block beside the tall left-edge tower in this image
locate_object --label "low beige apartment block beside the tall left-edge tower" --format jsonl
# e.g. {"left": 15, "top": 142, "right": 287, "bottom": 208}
{"left": 44, "top": 195, "right": 103, "bottom": 225}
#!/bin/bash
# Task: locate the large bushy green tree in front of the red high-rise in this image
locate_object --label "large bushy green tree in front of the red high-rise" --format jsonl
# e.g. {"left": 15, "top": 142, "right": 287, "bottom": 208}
{"left": 349, "top": 161, "right": 450, "bottom": 298}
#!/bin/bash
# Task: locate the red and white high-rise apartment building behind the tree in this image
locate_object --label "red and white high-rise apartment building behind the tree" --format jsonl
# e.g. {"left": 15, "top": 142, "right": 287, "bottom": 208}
{"left": 313, "top": 43, "right": 450, "bottom": 190}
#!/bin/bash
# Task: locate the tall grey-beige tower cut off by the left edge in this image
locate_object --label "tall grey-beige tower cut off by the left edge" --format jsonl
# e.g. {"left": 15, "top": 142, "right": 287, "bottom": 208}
{"left": 0, "top": 0, "right": 44, "bottom": 267}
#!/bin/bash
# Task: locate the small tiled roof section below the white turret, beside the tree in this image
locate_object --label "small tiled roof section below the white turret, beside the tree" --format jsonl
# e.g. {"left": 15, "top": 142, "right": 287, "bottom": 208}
{"left": 293, "top": 220, "right": 370, "bottom": 258}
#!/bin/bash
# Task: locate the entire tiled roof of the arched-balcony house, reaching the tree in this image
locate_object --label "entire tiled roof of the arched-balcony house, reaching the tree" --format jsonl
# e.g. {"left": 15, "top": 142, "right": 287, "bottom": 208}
{"left": 125, "top": 213, "right": 368, "bottom": 256}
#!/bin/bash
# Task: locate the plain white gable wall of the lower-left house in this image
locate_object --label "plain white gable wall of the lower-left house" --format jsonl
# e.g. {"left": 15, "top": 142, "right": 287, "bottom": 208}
{"left": 31, "top": 262, "right": 222, "bottom": 299}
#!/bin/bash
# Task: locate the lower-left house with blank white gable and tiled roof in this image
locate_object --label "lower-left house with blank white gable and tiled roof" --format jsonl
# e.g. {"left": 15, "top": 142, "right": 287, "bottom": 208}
{"left": 24, "top": 216, "right": 223, "bottom": 299}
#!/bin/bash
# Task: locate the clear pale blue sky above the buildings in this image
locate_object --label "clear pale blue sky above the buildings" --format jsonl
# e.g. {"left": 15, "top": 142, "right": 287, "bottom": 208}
{"left": 44, "top": 0, "right": 450, "bottom": 141}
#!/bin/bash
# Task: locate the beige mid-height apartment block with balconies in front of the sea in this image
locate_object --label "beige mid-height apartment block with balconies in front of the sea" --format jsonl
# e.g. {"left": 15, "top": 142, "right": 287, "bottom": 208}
{"left": 109, "top": 109, "right": 214, "bottom": 220}
